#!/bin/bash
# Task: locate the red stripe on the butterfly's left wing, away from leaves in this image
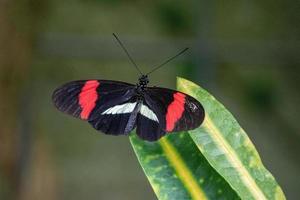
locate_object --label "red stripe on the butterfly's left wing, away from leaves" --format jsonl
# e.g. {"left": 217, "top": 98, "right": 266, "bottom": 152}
{"left": 79, "top": 80, "right": 100, "bottom": 119}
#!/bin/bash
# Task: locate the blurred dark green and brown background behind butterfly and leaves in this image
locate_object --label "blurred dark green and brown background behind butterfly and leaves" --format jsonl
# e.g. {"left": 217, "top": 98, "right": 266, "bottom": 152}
{"left": 0, "top": 0, "right": 300, "bottom": 200}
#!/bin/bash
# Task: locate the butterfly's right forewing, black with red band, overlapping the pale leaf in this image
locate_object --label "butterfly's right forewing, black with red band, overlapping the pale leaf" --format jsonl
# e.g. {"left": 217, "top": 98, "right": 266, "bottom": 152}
{"left": 145, "top": 87, "right": 204, "bottom": 135}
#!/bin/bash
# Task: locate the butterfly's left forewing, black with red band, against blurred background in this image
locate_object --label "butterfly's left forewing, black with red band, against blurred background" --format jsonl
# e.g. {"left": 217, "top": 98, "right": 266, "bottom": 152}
{"left": 52, "top": 80, "right": 134, "bottom": 120}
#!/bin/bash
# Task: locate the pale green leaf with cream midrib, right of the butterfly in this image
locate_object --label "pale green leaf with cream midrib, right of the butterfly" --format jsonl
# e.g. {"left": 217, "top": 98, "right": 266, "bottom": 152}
{"left": 177, "top": 78, "right": 285, "bottom": 199}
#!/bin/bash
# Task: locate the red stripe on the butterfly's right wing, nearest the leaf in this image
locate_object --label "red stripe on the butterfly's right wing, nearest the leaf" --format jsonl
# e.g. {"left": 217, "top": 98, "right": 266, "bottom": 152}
{"left": 166, "top": 92, "right": 186, "bottom": 132}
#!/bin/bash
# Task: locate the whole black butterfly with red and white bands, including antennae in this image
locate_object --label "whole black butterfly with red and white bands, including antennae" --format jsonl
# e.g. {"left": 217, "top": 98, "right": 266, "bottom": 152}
{"left": 52, "top": 34, "right": 205, "bottom": 141}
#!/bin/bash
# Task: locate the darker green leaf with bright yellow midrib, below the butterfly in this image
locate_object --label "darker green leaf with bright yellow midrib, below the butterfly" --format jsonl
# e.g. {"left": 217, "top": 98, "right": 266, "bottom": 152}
{"left": 130, "top": 132, "right": 239, "bottom": 200}
